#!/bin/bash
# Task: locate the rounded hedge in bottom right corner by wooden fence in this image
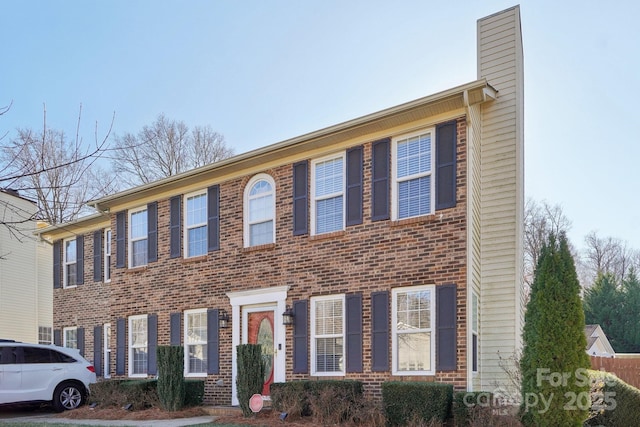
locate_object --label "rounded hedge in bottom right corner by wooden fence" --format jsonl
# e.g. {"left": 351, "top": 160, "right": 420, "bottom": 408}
{"left": 585, "top": 370, "right": 640, "bottom": 427}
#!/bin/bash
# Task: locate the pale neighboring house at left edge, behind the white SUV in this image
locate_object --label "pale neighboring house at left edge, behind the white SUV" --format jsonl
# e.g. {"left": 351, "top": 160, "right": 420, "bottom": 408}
{"left": 0, "top": 188, "right": 53, "bottom": 344}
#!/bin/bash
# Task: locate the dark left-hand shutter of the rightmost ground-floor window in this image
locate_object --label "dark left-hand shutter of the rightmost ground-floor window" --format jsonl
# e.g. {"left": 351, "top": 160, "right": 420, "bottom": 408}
{"left": 371, "top": 291, "right": 391, "bottom": 372}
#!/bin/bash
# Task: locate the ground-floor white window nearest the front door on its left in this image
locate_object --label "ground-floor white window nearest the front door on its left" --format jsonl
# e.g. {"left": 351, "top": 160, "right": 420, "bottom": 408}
{"left": 184, "top": 309, "right": 207, "bottom": 376}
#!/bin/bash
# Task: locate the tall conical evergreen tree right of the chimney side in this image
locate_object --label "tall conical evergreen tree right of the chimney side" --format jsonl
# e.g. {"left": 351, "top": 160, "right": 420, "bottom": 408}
{"left": 520, "top": 234, "right": 591, "bottom": 426}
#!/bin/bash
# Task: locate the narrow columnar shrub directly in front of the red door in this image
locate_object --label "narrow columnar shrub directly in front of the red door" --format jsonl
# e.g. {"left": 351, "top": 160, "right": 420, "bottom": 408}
{"left": 236, "top": 344, "right": 265, "bottom": 417}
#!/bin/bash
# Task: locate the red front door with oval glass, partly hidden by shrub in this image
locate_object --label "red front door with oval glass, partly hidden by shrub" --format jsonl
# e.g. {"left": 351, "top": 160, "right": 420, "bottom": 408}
{"left": 244, "top": 307, "right": 276, "bottom": 396}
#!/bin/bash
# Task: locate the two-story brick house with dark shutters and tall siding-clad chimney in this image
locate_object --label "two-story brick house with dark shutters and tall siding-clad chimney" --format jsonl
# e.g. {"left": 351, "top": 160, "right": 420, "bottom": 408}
{"left": 37, "top": 7, "right": 524, "bottom": 405}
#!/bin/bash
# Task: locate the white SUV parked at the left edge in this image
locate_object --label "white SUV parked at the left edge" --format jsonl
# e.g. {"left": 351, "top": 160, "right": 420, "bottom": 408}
{"left": 0, "top": 340, "right": 96, "bottom": 412}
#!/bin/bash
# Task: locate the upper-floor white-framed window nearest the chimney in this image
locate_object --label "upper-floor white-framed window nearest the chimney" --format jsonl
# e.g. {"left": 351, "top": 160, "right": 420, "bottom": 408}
{"left": 392, "top": 129, "right": 435, "bottom": 219}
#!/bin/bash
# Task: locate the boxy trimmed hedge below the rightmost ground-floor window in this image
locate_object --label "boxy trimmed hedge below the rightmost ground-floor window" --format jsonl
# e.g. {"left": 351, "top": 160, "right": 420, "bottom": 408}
{"left": 382, "top": 381, "right": 453, "bottom": 426}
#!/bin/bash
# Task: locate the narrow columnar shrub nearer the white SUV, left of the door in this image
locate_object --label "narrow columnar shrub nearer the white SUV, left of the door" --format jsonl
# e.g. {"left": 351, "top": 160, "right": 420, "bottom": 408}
{"left": 156, "top": 345, "right": 185, "bottom": 411}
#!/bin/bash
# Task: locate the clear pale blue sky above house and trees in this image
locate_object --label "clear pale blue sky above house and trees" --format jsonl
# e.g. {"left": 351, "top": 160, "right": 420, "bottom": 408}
{"left": 0, "top": 0, "right": 640, "bottom": 249}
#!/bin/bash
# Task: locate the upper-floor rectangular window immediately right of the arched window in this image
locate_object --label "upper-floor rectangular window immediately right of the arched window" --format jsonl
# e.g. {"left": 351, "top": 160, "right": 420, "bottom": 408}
{"left": 311, "top": 153, "right": 345, "bottom": 234}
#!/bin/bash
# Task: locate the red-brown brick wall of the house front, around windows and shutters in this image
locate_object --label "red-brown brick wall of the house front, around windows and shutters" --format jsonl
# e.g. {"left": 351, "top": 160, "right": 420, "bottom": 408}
{"left": 55, "top": 119, "right": 467, "bottom": 405}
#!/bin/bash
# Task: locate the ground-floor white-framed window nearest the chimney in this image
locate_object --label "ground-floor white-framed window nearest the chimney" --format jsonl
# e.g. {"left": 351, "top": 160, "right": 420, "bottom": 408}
{"left": 391, "top": 285, "right": 435, "bottom": 375}
